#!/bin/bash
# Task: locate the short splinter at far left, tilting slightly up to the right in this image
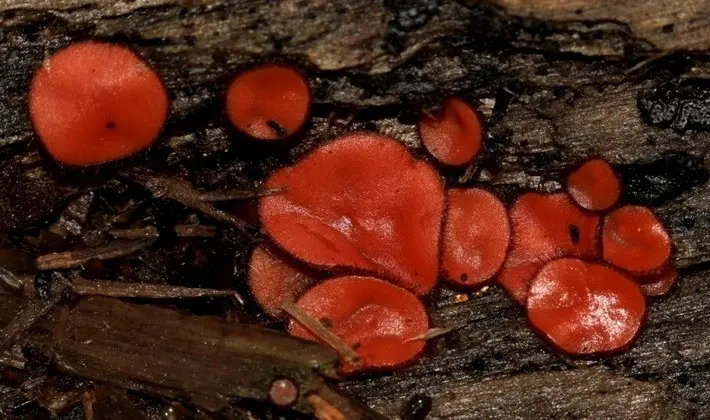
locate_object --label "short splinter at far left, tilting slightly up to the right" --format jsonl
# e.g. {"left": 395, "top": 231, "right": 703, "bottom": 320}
{"left": 35, "top": 239, "right": 155, "bottom": 270}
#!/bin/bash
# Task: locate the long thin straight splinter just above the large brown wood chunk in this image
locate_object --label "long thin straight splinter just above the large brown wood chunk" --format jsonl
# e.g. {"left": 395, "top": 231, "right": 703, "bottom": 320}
{"left": 71, "top": 279, "right": 241, "bottom": 300}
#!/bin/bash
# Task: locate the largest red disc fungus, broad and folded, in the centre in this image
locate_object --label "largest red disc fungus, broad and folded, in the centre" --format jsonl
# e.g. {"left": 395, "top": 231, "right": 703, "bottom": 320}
{"left": 259, "top": 133, "right": 445, "bottom": 294}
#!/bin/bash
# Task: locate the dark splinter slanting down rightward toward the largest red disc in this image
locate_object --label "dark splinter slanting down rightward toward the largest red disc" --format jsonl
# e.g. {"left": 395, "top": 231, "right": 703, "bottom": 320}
{"left": 120, "top": 168, "right": 252, "bottom": 238}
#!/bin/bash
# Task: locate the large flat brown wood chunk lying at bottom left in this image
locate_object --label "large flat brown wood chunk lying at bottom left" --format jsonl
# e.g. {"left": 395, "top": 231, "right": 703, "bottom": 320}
{"left": 0, "top": 295, "right": 390, "bottom": 419}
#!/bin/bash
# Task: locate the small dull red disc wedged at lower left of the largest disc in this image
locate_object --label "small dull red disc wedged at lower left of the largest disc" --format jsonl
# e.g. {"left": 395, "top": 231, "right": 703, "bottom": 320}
{"left": 249, "top": 245, "right": 315, "bottom": 318}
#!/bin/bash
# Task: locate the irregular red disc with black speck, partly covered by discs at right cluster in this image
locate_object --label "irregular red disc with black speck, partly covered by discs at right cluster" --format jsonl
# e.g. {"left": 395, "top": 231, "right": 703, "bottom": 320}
{"left": 498, "top": 193, "right": 599, "bottom": 304}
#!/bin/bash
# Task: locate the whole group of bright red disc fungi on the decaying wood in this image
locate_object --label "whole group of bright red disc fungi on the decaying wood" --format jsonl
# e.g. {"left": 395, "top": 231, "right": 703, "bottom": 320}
{"left": 29, "top": 41, "right": 678, "bottom": 373}
